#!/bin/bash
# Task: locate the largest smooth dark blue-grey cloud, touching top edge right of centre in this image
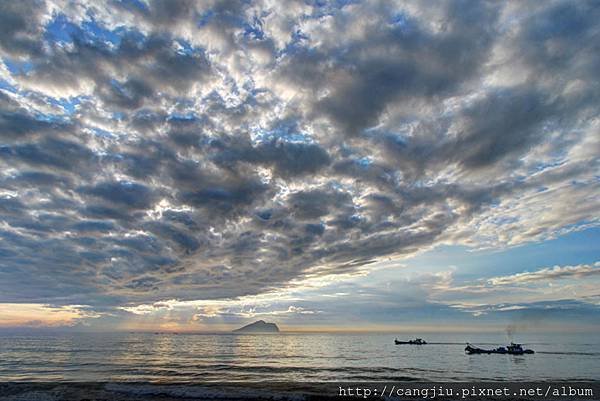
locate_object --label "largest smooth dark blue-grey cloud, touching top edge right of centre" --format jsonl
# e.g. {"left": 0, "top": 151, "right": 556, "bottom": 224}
{"left": 281, "top": 2, "right": 500, "bottom": 135}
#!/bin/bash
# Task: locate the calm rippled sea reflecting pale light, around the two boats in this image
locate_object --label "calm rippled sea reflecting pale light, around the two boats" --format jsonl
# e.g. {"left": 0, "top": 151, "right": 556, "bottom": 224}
{"left": 0, "top": 333, "right": 600, "bottom": 383}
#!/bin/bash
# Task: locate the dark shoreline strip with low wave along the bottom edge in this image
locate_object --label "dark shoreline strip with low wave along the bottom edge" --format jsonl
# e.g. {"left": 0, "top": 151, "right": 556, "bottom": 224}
{"left": 0, "top": 381, "right": 600, "bottom": 401}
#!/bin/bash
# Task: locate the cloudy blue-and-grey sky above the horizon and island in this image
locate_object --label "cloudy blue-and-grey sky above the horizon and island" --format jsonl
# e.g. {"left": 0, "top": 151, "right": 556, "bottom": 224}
{"left": 0, "top": 0, "right": 600, "bottom": 332}
